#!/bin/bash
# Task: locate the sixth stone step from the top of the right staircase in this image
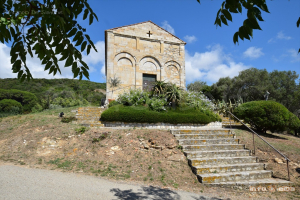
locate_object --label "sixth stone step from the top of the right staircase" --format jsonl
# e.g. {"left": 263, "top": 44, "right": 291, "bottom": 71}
{"left": 189, "top": 156, "right": 256, "bottom": 167}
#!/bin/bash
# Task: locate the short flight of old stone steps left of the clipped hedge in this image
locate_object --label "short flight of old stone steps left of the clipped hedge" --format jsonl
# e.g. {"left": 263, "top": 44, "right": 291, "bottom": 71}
{"left": 76, "top": 107, "right": 104, "bottom": 127}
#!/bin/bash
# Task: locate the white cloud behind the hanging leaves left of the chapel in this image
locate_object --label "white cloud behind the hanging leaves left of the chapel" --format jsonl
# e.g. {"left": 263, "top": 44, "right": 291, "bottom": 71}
{"left": 0, "top": 41, "right": 105, "bottom": 79}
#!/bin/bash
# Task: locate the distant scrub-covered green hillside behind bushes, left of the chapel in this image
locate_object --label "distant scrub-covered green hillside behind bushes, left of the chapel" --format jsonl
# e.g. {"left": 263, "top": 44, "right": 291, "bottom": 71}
{"left": 0, "top": 78, "right": 106, "bottom": 108}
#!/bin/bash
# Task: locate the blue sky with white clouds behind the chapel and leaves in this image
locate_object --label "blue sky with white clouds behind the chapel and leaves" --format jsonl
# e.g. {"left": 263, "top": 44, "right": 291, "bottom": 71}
{"left": 0, "top": 0, "right": 300, "bottom": 85}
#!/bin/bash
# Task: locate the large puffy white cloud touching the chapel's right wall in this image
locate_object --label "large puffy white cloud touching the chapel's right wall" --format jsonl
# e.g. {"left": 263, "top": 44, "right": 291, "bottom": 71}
{"left": 185, "top": 45, "right": 250, "bottom": 84}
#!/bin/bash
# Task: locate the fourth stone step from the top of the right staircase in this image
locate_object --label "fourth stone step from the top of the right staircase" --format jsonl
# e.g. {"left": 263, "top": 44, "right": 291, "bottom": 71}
{"left": 182, "top": 144, "right": 245, "bottom": 151}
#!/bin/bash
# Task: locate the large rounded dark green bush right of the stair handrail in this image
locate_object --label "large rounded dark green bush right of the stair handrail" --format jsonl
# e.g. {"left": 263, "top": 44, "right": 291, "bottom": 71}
{"left": 233, "top": 101, "right": 300, "bottom": 132}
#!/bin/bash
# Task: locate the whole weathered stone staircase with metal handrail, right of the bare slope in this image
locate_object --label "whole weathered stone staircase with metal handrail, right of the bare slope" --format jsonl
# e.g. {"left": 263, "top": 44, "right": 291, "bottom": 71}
{"left": 171, "top": 129, "right": 291, "bottom": 186}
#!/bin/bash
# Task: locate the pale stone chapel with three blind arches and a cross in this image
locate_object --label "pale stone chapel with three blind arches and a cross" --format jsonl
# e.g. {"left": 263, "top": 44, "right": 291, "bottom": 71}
{"left": 105, "top": 21, "right": 186, "bottom": 99}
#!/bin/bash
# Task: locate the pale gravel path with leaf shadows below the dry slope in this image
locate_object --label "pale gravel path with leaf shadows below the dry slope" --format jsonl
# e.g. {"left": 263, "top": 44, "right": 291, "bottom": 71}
{"left": 0, "top": 165, "right": 226, "bottom": 200}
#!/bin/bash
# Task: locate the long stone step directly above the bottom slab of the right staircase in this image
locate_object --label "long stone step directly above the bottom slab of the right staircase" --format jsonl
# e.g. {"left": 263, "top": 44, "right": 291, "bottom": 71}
{"left": 197, "top": 170, "right": 272, "bottom": 184}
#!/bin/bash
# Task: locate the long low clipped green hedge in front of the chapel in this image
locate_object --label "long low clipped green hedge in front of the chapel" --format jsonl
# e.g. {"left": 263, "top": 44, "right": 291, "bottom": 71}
{"left": 101, "top": 105, "right": 221, "bottom": 124}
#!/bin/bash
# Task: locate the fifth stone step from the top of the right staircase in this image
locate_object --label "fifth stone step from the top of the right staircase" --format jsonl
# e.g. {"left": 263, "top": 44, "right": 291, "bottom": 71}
{"left": 184, "top": 149, "right": 250, "bottom": 159}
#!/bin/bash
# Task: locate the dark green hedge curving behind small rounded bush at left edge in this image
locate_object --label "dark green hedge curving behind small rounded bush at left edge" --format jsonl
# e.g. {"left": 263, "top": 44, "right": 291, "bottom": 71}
{"left": 0, "top": 89, "right": 37, "bottom": 112}
